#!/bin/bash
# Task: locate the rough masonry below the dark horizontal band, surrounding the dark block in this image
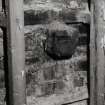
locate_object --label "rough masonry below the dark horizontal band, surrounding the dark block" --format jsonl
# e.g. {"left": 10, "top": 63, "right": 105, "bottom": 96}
{"left": 25, "top": 24, "right": 89, "bottom": 105}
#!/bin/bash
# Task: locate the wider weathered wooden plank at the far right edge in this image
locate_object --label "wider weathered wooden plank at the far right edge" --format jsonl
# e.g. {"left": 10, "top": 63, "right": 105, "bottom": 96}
{"left": 94, "top": 0, "right": 105, "bottom": 105}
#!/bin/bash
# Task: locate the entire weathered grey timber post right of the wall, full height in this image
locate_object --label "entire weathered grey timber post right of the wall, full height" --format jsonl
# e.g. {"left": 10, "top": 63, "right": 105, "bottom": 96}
{"left": 90, "top": 0, "right": 105, "bottom": 105}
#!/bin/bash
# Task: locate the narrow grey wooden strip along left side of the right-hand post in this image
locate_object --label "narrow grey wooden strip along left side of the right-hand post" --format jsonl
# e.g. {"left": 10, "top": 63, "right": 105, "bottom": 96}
{"left": 90, "top": 0, "right": 96, "bottom": 105}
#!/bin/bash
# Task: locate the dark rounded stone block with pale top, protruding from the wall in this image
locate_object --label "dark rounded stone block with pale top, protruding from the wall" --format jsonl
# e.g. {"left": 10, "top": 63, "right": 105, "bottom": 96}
{"left": 45, "top": 21, "right": 79, "bottom": 59}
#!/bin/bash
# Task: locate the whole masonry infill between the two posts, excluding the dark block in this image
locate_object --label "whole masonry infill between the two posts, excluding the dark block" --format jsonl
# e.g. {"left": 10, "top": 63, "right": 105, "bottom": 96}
{"left": 24, "top": 0, "right": 89, "bottom": 105}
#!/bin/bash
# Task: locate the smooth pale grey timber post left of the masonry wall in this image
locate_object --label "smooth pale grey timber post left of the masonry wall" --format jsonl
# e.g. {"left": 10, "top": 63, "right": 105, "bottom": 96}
{"left": 4, "top": 0, "right": 26, "bottom": 105}
